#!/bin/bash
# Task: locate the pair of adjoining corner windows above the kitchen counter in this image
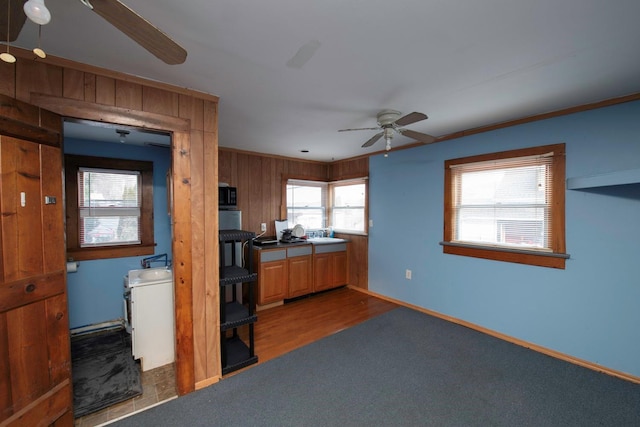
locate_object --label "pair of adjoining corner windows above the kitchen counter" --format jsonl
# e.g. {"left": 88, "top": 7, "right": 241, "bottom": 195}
{"left": 286, "top": 178, "right": 367, "bottom": 233}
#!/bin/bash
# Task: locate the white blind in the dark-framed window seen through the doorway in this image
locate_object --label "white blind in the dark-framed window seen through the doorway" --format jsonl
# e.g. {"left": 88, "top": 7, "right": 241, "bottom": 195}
{"left": 78, "top": 167, "right": 141, "bottom": 247}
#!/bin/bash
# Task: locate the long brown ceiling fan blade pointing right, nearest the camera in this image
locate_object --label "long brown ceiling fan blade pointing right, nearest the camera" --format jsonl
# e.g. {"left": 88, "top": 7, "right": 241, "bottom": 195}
{"left": 85, "top": 0, "right": 187, "bottom": 65}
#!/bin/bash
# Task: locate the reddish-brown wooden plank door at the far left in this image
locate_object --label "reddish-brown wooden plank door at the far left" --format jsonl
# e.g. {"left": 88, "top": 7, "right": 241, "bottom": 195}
{"left": 0, "top": 96, "right": 73, "bottom": 426}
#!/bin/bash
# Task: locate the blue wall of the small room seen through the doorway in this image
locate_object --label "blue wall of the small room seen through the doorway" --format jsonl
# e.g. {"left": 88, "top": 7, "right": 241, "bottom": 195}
{"left": 64, "top": 138, "right": 172, "bottom": 329}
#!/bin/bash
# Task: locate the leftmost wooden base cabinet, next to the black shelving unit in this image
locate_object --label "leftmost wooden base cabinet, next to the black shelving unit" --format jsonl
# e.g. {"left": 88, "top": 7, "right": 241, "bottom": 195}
{"left": 256, "top": 248, "right": 288, "bottom": 305}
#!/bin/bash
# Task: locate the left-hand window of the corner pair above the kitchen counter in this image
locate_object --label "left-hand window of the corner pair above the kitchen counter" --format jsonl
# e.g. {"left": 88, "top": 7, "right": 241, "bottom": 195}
{"left": 287, "top": 179, "right": 327, "bottom": 230}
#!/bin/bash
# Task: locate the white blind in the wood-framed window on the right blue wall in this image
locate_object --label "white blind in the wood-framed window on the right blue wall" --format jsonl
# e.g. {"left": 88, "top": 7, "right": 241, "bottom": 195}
{"left": 451, "top": 153, "right": 553, "bottom": 251}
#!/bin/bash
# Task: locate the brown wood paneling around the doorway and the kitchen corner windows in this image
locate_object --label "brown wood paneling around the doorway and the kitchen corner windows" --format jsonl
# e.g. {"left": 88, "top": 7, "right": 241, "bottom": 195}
{"left": 0, "top": 48, "right": 368, "bottom": 400}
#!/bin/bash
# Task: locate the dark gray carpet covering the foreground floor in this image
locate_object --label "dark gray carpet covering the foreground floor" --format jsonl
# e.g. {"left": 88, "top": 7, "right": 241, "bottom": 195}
{"left": 114, "top": 308, "right": 640, "bottom": 427}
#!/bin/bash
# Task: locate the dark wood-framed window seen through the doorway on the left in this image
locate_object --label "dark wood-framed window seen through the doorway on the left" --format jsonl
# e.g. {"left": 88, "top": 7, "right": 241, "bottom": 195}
{"left": 65, "top": 155, "right": 154, "bottom": 260}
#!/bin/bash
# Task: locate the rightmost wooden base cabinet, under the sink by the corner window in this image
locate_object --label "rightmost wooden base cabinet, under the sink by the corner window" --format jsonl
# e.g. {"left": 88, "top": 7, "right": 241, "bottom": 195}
{"left": 313, "top": 243, "right": 349, "bottom": 292}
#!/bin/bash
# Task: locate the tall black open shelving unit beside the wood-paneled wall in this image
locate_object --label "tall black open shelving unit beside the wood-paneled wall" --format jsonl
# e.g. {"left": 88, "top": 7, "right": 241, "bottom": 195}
{"left": 219, "top": 230, "right": 258, "bottom": 375}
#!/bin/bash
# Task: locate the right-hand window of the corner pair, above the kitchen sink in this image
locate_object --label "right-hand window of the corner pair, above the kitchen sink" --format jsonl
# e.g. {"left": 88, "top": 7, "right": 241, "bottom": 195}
{"left": 329, "top": 179, "right": 367, "bottom": 233}
